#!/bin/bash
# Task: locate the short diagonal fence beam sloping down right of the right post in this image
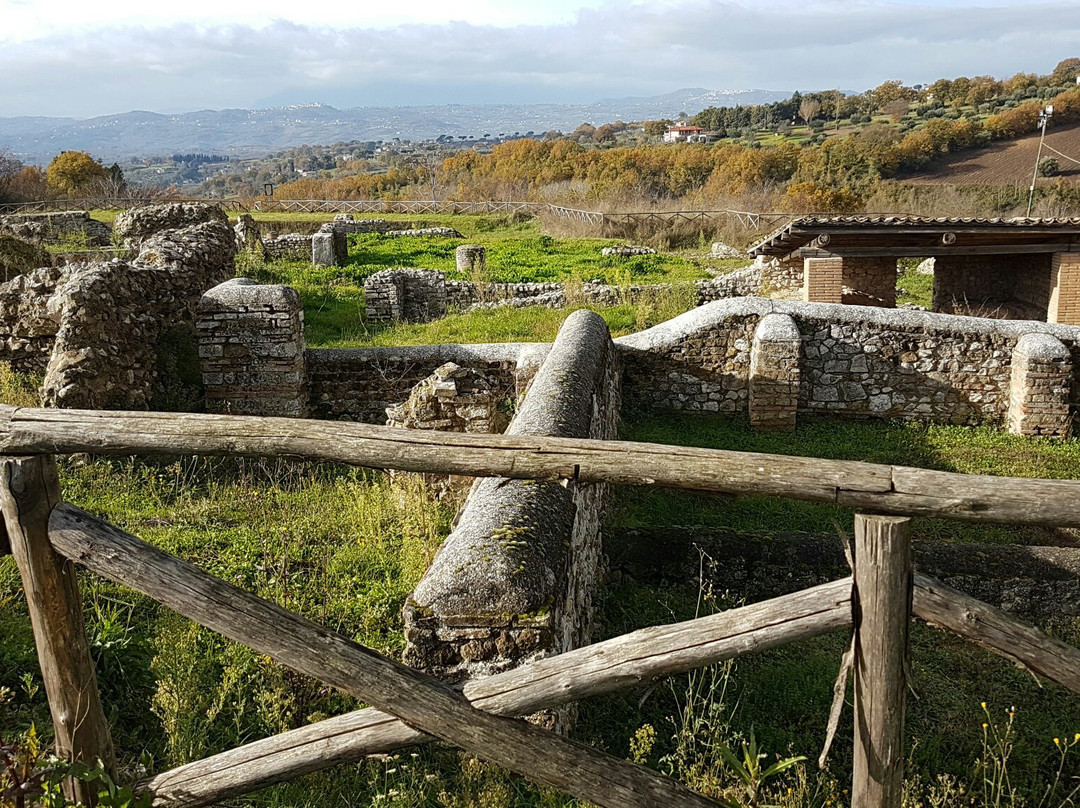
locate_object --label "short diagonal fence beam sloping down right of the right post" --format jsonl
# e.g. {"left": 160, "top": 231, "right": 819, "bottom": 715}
{"left": 914, "top": 574, "right": 1080, "bottom": 695}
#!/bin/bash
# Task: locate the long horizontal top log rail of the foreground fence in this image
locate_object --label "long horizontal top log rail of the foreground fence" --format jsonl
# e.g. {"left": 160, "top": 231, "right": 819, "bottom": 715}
{"left": 6, "top": 407, "right": 1080, "bottom": 527}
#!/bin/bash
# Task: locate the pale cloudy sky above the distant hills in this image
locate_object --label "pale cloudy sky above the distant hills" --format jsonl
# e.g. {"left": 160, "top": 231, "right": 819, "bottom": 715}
{"left": 0, "top": 0, "right": 1080, "bottom": 118}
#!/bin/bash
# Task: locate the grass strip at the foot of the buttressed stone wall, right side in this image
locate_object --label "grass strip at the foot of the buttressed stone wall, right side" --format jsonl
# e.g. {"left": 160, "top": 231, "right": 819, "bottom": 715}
{"left": 610, "top": 413, "right": 1080, "bottom": 543}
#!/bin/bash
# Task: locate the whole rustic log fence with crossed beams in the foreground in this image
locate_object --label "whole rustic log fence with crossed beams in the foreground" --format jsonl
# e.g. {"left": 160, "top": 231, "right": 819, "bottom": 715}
{"left": 0, "top": 407, "right": 1080, "bottom": 808}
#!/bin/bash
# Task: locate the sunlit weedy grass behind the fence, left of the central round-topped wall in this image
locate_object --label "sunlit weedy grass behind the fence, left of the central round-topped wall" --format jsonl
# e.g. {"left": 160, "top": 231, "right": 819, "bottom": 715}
{"left": 0, "top": 458, "right": 454, "bottom": 766}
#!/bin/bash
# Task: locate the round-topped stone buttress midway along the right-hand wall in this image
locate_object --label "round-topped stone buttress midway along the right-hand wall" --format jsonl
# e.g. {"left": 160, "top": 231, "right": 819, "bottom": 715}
{"left": 750, "top": 313, "right": 802, "bottom": 431}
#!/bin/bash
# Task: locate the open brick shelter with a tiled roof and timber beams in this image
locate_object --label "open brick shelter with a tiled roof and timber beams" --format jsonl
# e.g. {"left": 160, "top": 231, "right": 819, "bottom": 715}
{"left": 750, "top": 216, "right": 1080, "bottom": 325}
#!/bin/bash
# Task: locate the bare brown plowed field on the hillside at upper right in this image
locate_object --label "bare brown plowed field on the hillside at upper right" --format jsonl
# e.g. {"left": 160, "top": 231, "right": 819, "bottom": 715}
{"left": 906, "top": 119, "right": 1080, "bottom": 186}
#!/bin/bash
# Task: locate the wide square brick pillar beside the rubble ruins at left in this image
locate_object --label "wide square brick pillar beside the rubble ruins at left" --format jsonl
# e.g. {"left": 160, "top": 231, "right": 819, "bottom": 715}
{"left": 198, "top": 278, "right": 308, "bottom": 418}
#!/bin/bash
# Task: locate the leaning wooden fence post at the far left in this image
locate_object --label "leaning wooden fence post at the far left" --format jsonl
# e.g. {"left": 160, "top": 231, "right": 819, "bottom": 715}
{"left": 0, "top": 455, "right": 116, "bottom": 805}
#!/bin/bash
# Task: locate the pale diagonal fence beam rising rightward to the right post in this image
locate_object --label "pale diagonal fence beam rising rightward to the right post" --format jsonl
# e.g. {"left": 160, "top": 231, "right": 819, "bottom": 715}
{"left": 144, "top": 578, "right": 851, "bottom": 808}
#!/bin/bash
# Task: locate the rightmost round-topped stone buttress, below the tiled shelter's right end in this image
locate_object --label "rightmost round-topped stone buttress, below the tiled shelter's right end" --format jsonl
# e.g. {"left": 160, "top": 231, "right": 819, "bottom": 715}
{"left": 1009, "top": 334, "right": 1072, "bottom": 437}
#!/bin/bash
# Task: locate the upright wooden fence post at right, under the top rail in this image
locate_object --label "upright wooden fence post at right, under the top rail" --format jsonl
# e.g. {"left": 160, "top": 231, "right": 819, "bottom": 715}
{"left": 851, "top": 513, "right": 913, "bottom": 808}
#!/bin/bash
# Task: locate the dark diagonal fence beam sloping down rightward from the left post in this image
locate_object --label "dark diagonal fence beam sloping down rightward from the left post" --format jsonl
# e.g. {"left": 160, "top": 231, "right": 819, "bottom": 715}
{"left": 50, "top": 504, "right": 716, "bottom": 808}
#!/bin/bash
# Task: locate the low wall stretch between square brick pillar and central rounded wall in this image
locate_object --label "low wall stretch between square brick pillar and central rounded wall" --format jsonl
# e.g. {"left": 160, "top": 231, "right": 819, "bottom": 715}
{"left": 307, "top": 342, "right": 550, "bottom": 423}
